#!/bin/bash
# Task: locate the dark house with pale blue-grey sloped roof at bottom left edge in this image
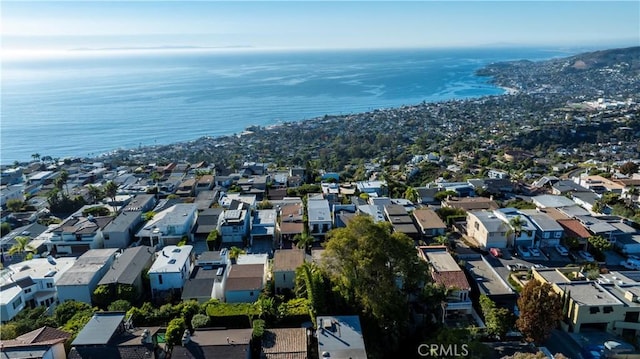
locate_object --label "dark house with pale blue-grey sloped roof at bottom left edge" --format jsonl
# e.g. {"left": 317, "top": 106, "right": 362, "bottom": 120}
{"left": 69, "top": 312, "right": 168, "bottom": 359}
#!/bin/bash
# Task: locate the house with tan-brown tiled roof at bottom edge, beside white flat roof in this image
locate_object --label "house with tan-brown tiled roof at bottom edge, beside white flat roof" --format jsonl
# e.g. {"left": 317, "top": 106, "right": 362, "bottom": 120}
{"left": 260, "top": 328, "right": 310, "bottom": 359}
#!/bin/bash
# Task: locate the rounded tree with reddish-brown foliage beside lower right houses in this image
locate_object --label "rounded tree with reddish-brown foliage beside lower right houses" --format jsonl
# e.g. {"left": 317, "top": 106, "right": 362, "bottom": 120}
{"left": 516, "top": 279, "right": 562, "bottom": 345}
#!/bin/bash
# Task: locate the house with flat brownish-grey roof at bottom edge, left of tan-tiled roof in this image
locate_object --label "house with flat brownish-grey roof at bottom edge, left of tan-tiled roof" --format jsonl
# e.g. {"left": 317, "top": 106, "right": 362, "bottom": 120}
{"left": 171, "top": 328, "right": 252, "bottom": 359}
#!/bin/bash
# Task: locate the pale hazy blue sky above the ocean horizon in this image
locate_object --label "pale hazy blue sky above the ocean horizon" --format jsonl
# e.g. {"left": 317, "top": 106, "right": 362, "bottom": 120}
{"left": 0, "top": 0, "right": 640, "bottom": 51}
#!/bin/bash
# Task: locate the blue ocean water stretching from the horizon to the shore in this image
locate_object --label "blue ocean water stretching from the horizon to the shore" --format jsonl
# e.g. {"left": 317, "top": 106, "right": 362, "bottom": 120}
{"left": 0, "top": 48, "right": 573, "bottom": 164}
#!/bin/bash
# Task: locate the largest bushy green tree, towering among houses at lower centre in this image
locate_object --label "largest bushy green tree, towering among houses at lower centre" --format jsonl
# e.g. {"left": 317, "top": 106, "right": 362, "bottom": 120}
{"left": 322, "top": 215, "right": 426, "bottom": 346}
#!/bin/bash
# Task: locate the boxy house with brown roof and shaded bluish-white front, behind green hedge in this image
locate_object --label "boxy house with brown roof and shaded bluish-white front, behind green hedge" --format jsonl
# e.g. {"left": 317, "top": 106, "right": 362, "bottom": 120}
{"left": 224, "top": 263, "right": 266, "bottom": 303}
